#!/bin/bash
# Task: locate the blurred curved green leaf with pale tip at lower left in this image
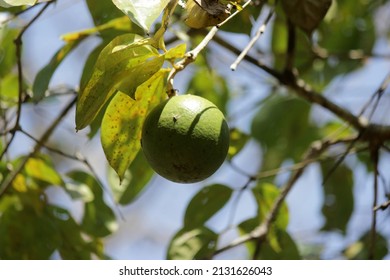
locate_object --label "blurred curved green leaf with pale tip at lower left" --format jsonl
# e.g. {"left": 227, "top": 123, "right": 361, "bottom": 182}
{"left": 67, "top": 171, "right": 118, "bottom": 237}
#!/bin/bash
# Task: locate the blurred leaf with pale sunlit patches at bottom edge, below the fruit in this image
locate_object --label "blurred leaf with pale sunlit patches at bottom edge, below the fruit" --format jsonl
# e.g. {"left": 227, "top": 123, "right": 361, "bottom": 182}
{"left": 167, "top": 227, "right": 218, "bottom": 260}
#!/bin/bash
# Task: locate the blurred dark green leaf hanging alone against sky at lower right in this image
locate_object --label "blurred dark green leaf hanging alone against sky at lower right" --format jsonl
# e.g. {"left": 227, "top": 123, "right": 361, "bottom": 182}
{"left": 321, "top": 161, "right": 354, "bottom": 234}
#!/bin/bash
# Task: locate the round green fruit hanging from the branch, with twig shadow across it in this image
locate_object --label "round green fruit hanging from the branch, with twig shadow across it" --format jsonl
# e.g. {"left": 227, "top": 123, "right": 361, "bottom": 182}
{"left": 141, "top": 94, "right": 229, "bottom": 183}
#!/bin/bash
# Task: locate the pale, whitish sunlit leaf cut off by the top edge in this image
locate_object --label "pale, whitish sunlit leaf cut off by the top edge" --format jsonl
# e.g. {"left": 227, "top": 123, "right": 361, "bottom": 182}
{"left": 112, "top": 0, "right": 170, "bottom": 31}
